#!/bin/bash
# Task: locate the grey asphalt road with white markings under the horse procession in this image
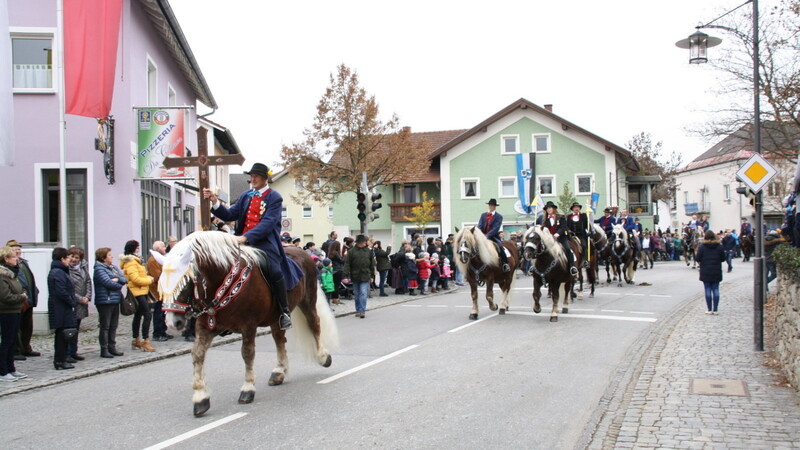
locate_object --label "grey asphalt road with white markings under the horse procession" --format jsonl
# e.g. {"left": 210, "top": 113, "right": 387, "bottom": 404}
{"left": 0, "top": 263, "right": 752, "bottom": 449}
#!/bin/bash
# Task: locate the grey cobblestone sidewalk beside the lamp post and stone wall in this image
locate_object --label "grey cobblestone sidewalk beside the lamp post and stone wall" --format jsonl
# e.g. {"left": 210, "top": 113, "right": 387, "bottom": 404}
{"left": 579, "top": 282, "right": 800, "bottom": 449}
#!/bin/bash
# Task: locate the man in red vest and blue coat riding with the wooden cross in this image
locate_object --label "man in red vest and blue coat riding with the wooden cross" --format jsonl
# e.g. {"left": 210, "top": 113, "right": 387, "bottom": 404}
{"left": 203, "top": 163, "right": 301, "bottom": 330}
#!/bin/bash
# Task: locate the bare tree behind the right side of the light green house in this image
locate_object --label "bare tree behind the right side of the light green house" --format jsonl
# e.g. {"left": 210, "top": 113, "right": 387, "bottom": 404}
{"left": 628, "top": 132, "right": 683, "bottom": 203}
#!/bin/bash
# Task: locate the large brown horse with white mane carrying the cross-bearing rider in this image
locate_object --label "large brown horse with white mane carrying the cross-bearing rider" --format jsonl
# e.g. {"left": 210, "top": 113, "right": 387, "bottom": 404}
{"left": 158, "top": 231, "right": 338, "bottom": 417}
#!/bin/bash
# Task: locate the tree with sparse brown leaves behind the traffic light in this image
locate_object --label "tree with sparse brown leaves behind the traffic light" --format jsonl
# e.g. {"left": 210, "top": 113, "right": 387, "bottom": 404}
{"left": 281, "top": 64, "right": 430, "bottom": 202}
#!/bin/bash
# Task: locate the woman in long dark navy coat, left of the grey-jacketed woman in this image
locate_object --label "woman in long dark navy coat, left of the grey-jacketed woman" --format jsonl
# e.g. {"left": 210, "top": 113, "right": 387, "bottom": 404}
{"left": 47, "top": 247, "right": 78, "bottom": 370}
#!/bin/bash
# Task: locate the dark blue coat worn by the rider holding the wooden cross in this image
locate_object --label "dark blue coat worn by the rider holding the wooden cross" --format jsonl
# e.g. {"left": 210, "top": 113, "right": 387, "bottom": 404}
{"left": 211, "top": 189, "right": 303, "bottom": 290}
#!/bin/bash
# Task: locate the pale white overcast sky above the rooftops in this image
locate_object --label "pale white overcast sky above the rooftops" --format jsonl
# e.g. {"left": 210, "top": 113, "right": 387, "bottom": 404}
{"left": 170, "top": 0, "right": 770, "bottom": 171}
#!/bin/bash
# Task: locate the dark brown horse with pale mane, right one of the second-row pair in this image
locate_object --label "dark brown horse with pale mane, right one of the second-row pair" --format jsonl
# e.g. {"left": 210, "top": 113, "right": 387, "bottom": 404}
{"left": 523, "top": 225, "right": 575, "bottom": 322}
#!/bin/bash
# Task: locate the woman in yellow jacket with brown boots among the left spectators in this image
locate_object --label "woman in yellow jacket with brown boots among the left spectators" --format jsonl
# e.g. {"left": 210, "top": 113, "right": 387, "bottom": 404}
{"left": 119, "top": 240, "right": 156, "bottom": 352}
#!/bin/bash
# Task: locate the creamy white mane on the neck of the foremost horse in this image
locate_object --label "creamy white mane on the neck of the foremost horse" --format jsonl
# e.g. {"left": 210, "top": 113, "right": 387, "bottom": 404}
{"left": 187, "top": 231, "right": 264, "bottom": 271}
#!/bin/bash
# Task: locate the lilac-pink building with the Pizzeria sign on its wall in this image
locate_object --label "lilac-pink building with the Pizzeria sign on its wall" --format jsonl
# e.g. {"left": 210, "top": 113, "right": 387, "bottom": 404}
{"left": 0, "top": 0, "right": 239, "bottom": 330}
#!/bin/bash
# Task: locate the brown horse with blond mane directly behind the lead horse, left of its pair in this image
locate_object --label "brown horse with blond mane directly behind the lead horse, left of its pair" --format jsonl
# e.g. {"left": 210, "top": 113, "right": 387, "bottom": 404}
{"left": 454, "top": 226, "right": 519, "bottom": 320}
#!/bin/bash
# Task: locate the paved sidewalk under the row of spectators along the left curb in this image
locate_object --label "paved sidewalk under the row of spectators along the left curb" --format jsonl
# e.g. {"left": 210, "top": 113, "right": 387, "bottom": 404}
{"left": 0, "top": 286, "right": 458, "bottom": 397}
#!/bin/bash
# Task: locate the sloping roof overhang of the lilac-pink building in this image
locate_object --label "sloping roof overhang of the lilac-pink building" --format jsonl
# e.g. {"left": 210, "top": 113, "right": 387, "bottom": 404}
{"left": 139, "top": 0, "right": 217, "bottom": 109}
